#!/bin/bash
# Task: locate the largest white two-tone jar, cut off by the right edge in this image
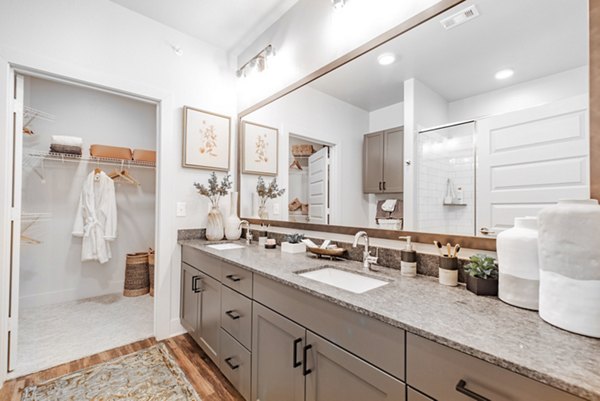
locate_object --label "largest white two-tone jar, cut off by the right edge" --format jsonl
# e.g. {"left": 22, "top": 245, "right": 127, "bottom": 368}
{"left": 538, "top": 199, "right": 600, "bottom": 338}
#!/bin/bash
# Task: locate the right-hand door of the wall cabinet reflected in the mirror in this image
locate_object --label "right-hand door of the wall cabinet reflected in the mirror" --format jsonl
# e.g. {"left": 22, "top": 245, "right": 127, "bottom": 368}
{"left": 383, "top": 128, "right": 404, "bottom": 192}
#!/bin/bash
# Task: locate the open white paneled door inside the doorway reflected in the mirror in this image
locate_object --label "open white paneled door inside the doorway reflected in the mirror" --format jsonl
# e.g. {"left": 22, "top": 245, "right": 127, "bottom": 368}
{"left": 308, "top": 146, "right": 329, "bottom": 224}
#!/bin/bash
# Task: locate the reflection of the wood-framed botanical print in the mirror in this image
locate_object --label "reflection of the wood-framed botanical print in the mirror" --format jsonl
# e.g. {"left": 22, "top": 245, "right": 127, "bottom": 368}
{"left": 242, "top": 121, "right": 279, "bottom": 176}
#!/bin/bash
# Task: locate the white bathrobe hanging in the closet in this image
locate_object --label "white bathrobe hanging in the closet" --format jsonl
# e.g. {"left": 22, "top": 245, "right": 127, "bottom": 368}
{"left": 73, "top": 171, "right": 117, "bottom": 263}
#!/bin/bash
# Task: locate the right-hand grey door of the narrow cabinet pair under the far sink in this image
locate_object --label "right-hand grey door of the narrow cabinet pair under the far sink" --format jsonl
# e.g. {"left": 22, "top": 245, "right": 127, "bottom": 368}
{"left": 198, "top": 274, "right": 221, "bottom": 363}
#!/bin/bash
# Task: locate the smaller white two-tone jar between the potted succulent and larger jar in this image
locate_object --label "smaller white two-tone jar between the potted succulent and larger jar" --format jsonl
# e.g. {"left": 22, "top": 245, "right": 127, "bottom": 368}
{"left": 496, "top": 217, "right": 540, "bottom": 310}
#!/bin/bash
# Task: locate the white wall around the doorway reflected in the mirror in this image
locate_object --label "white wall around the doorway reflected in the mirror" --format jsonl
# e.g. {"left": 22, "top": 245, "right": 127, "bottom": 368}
{"left": 241, "top": 86, "right": 369, "bottom": 226}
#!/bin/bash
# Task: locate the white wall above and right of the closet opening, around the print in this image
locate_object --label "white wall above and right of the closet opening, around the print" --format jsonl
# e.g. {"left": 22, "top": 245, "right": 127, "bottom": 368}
{"left": 0, "top": 0, "right": 236, "bottom": 339}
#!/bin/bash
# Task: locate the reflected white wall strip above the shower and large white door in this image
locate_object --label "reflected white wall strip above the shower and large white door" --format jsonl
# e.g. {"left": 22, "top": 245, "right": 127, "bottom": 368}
{"left": 448, "top": 66, "right": 589, "bottom": 121}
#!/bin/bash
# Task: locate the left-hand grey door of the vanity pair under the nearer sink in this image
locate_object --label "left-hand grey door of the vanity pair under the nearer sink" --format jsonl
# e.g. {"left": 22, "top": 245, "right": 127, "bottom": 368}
{"left": 252, "top": 302, "right": 306, "bottom": 401}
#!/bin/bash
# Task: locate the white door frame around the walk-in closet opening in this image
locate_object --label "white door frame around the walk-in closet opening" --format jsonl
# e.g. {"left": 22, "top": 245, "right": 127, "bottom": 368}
{"left": 0, "top": 49, "right": 173, "bottom": 387}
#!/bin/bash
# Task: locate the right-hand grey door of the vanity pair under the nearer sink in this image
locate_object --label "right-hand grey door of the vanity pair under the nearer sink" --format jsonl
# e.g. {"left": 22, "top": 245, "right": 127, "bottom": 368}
{"left": 305, "top": 331, "right": 405, "bottom": 401}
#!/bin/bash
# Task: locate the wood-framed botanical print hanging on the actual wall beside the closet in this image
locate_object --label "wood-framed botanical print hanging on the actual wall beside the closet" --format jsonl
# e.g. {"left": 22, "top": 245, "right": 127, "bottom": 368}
{"left": 182, "top": 106, "right": 231, "bottom": 171}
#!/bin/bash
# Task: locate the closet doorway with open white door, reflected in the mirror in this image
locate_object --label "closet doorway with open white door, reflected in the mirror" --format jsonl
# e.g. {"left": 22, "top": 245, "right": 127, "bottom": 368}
{"left": 288, "top": 134, "right": 330, "bottom": 224}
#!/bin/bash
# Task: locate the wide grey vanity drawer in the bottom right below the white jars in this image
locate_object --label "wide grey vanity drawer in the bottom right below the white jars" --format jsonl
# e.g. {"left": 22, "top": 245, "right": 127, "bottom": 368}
{"left": 406, "top": 333, "right": 581, "bottom": 401}
